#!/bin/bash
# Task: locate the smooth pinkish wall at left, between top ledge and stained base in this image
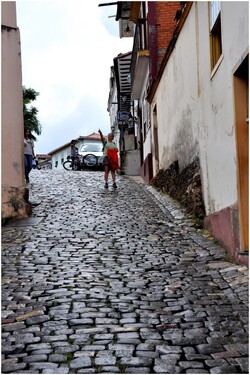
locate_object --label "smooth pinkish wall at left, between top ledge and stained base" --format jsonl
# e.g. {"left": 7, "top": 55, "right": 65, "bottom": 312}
{"left": 1, "top": 14, "right": 24, "bottom": 187}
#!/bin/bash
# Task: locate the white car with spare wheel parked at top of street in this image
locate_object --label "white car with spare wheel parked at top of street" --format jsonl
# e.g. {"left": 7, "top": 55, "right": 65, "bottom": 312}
{"left": 78, "top": 142, "right": 103, "bottom": 167}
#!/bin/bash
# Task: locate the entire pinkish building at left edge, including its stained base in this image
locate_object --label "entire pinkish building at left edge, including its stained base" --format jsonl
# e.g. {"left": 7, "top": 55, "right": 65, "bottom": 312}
{"left": 1, "top": 1, "right": 31, "bottom": 221}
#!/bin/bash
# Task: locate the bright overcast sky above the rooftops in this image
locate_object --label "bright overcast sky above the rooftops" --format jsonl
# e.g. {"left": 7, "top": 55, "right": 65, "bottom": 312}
{"left": 16, "top": 0, "right": 132, "bottom": 154}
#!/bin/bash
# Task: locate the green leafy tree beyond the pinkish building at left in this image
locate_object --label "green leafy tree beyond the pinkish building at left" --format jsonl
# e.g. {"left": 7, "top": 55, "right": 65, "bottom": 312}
{"left": 23, "top": 86, "right": 42, "bottom": 141}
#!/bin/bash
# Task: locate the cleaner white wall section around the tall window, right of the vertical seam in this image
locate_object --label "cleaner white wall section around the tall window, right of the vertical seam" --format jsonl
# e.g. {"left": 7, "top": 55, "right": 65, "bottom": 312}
{"left": 196, "top": 2, "right": 249, "bottom": 214}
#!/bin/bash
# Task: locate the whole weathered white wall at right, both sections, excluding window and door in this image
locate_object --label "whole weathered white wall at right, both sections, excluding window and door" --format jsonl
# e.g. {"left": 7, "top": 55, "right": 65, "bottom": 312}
{"left": 152, "top": 2, "right": 249, "bottom": 214}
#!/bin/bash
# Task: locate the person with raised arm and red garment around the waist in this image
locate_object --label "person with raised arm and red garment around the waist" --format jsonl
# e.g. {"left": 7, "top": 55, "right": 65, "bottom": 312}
{"left": 98, "top": 129, "right": 119, "bottom": 189}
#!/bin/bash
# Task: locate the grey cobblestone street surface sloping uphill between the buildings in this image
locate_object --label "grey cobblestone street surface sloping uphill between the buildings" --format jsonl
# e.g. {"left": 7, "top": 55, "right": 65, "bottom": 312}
{"left": 2, "top": 170, "right": 249, "bottom": 374}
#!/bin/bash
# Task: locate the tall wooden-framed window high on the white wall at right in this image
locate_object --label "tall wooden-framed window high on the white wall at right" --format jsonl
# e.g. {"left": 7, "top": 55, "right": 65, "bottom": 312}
{"left": 209, "top": 1, "right": 222, "bottom": 70}
